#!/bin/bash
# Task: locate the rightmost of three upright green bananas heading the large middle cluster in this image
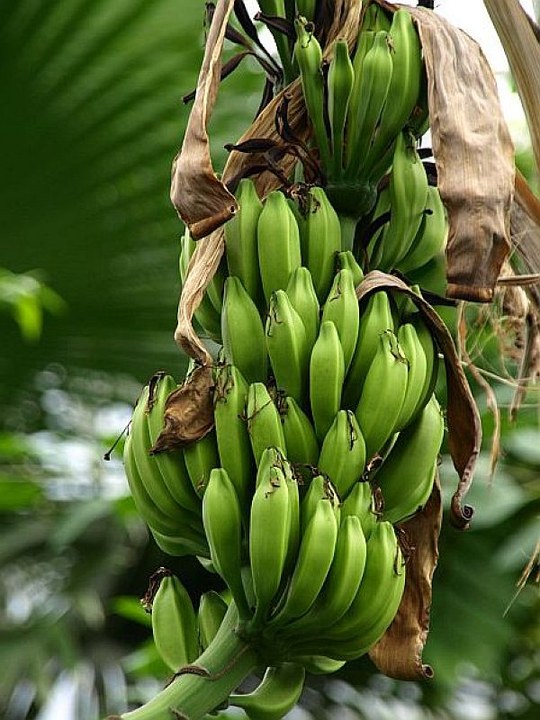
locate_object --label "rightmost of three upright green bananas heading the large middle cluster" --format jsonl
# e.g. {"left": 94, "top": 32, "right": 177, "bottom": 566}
{"left": 301, "top": 187, "right": 341, "bottom": 302}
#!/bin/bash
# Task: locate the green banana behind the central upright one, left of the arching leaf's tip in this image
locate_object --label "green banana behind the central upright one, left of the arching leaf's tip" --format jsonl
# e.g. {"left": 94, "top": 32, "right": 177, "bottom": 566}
{"left": 321, "top": 268, "right": 359, "bottom": 372}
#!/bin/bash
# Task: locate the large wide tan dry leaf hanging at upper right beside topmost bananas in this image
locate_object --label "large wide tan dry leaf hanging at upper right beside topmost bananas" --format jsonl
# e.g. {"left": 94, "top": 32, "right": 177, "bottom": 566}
{"left": 407, "top": 7, "right": 514, "bottom": 302}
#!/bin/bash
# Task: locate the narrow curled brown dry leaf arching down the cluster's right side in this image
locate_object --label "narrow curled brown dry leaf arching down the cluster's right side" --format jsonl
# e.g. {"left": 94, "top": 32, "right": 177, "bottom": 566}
{"left": 356, "top": 270, "right": 482, "bottom": 529}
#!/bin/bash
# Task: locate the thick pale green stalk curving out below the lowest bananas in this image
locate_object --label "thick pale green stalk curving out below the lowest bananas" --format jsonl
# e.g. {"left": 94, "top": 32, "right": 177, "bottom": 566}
{"left": 117, "top": 604, "right": 261, "bottom": 720}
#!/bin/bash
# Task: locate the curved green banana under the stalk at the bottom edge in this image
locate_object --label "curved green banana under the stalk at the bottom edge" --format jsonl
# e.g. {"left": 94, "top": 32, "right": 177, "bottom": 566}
{"left": 229, "top": 662, "right": 306, "bottom": 720}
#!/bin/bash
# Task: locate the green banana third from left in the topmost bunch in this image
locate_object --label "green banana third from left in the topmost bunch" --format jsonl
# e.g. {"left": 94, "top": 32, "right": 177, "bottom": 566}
{"left": 345, "top": 30, "right": 394, "bottom": 180}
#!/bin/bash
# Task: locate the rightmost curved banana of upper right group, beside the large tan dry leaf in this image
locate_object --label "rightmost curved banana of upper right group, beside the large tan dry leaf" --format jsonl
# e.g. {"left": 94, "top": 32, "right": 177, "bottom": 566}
{"left": 397, "top": 185, "right": 448, "bottom": 273}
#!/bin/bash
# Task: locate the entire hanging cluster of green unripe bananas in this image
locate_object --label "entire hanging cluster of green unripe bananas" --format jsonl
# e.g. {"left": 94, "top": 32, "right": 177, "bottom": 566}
{"left": 124, "top": 2, "right": 452, "bottom": 718}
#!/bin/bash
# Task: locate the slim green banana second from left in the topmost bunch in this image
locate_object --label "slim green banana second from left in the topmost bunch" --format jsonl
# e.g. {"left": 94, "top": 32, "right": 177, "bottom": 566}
{"left": 327, "top": 40, "right": 354, "bottom": 178}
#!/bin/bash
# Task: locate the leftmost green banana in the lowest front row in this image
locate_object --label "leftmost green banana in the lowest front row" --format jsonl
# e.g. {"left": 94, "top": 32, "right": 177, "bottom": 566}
{"left": 202, "top": 468, "right": 247, "bottom": 616}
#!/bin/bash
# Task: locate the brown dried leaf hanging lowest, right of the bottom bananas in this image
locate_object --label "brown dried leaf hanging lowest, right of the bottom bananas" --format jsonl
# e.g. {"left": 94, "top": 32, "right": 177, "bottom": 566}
{"left": 369, "top": 477, "right": 442, "bottom": 680}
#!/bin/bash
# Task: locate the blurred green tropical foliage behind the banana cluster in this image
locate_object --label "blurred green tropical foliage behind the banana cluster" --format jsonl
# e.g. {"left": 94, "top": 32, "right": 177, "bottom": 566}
{"left": 0, "top": 0, "right": 540, "bottom": 720}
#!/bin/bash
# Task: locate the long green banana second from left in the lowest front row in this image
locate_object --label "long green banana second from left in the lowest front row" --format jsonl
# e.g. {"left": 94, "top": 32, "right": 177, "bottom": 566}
{"left": 249, "top": 465, "right": 291, "bottom": 626}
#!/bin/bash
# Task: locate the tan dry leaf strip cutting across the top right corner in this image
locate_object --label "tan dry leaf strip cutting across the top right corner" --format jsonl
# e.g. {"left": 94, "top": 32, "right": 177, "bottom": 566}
{"left": 484, "top": 0, "right": 540, "bottom": 171}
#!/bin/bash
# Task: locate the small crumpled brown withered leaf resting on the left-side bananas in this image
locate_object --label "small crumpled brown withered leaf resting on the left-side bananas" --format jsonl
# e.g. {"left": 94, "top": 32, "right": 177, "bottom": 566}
{"left": 151, "top": 365, "right": 214, "bottom": 454}
